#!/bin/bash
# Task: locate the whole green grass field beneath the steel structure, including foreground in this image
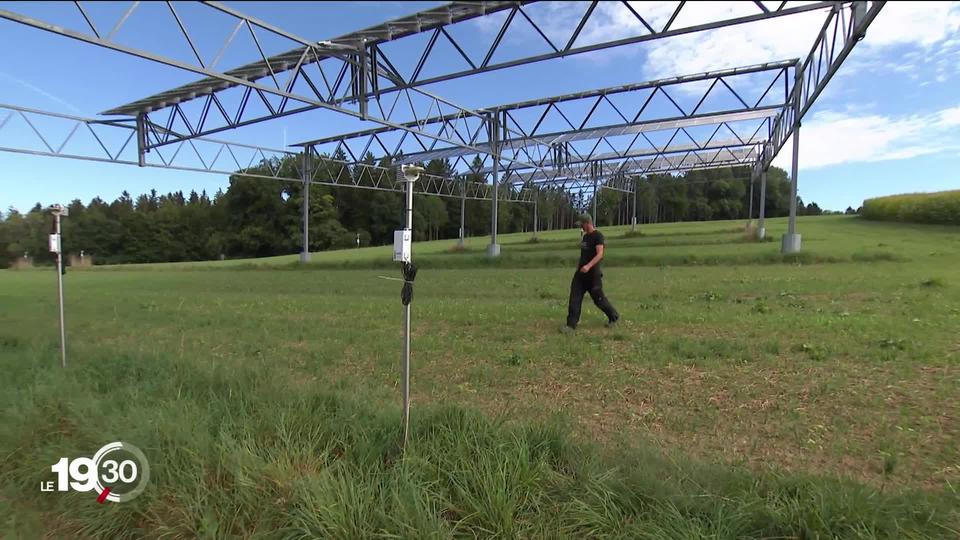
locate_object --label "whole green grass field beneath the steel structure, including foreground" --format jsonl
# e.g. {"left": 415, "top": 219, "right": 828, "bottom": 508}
{"left": 0, "top": 216, "right": 960, "bottom": 538}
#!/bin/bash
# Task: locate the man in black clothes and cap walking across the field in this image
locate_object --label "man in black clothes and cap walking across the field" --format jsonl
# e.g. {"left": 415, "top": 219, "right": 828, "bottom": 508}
{"left": 564, "top": 214, "right": 620, "bottom": 332}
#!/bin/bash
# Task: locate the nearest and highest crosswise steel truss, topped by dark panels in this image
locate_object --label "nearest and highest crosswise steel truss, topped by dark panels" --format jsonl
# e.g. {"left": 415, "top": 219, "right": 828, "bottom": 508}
{"left": 108, "top": 1, "right": 834, "bottom": 150}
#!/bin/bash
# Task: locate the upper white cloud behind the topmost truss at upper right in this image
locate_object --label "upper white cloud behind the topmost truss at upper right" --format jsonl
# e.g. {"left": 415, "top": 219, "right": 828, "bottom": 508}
{"left": 476, "top": 1, "right": 960, "bottom": 84}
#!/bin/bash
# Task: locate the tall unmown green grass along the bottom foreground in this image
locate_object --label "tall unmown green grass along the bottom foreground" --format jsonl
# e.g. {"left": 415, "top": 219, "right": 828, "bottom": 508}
{"left": 0, "top": 343, "right": 960, "bottom": 539}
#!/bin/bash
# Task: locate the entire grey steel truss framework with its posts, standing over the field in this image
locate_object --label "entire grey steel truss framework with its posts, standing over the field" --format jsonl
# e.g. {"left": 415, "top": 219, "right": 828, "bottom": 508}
{"left": 0, "top": 1, "right": 884, "bottom": 260}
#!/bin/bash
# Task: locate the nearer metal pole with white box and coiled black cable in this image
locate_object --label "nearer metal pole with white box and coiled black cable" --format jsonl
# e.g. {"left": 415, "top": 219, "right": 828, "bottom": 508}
{"left": 393, "top": 166, "right": 423, "bottom": 446}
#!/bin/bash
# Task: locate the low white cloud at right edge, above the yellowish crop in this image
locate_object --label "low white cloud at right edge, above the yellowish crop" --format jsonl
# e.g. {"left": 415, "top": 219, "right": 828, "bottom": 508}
{"left": 775, "top": 106, "right": 960, "bottom": 169}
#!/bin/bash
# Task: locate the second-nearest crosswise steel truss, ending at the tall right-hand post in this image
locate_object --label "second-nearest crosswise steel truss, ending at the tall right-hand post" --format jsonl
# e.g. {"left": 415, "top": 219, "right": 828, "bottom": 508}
{"left": 298, "top": 60, "right": 796, "bottom": 168}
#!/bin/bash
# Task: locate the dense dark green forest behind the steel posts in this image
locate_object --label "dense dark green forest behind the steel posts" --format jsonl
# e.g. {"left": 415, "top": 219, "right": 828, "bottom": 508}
{"left": 0, "top": 153, "right": 822, "bottom": 266}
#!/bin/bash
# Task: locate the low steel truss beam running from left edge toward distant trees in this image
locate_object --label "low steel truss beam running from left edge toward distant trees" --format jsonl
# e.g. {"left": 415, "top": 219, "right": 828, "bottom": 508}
{"left": 0, "top": 104, "right": 532, "bottom": 202}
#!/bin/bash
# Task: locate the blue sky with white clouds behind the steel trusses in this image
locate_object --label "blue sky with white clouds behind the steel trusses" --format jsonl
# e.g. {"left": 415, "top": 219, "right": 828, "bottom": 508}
{"left": 0, "top": 2, "right": 960, "bottom": 210}
